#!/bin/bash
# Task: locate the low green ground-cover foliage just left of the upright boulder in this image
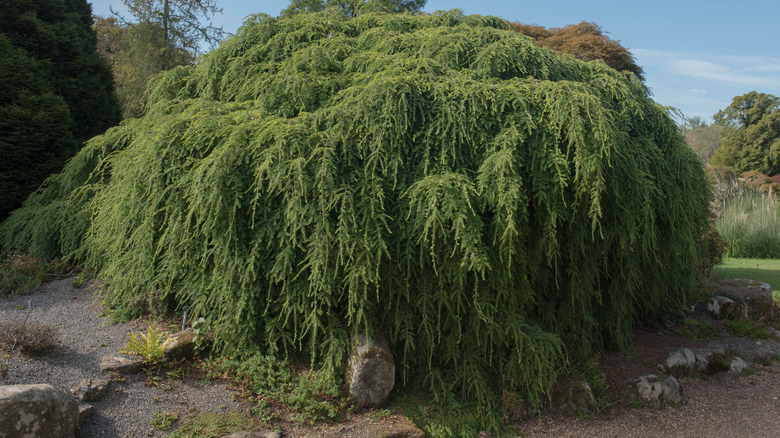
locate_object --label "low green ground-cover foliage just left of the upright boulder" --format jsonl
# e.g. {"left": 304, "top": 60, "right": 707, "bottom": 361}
{"left": 214, "top": 354, "right": 347, "bottom": 423}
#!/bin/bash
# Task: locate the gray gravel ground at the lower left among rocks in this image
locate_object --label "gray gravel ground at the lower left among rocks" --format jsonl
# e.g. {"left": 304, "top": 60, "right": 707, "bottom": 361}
{"left": 0, "top": 278, "right": 239, "bottom": 437}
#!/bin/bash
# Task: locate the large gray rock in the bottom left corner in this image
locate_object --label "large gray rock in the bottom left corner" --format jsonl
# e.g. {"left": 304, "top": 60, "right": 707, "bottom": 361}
{"left": 0, "top": 385, "right": 79, "bottom": 438}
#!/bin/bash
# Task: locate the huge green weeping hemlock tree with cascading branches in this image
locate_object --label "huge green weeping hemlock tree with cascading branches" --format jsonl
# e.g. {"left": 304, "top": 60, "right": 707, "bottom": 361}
{"left": 2, "top": 11, "right": 708, "bottom": 405}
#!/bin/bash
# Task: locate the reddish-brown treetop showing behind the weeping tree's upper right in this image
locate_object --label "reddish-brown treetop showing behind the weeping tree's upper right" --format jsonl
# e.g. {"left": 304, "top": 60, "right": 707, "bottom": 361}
{"left": 512, "top": 21, "right": 644, "bottom": 80}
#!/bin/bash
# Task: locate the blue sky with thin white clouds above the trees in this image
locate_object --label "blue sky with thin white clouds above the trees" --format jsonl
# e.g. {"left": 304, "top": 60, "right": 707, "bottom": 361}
{"left": 91, "top": 0, "right": 780, "bottom": 120}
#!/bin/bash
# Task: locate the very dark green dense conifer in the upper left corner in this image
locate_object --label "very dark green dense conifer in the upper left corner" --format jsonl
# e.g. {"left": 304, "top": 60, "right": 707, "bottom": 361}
{"left": 0, "top": 0, "right": 120, "bottom": 220}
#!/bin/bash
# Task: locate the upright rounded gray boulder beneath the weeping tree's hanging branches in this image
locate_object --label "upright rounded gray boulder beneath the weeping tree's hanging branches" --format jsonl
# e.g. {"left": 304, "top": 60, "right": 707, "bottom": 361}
{"left": 347, "top": 334, "right": 395, "bottom": 407}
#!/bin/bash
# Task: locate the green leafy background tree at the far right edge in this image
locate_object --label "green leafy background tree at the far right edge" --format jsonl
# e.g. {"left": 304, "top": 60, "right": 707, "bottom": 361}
{"left": 710, "top": 91, "right": 780, "bottom": 176}
